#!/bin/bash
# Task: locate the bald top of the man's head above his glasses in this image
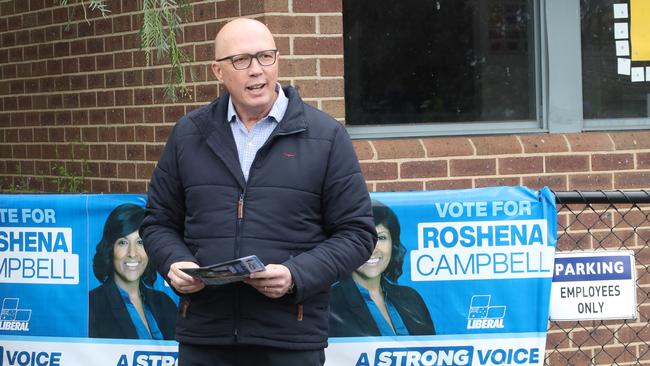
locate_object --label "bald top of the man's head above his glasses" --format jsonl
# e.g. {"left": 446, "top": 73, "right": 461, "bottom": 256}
{"left": 214, "top": 18, "right": 276, "bottom": 60}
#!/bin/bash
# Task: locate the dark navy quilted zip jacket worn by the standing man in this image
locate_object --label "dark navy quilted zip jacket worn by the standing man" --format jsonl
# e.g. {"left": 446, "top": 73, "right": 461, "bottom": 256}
{"left": 141, "top": 87, "right": 376, "bottom": 349}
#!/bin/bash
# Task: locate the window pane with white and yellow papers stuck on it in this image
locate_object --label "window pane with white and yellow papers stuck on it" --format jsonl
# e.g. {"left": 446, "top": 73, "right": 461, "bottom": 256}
{"left": 580, "top": 0, "right": 650, "bottom": 119}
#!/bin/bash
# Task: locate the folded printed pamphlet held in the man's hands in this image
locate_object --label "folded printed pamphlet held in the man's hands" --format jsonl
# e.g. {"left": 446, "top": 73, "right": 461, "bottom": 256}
{"left": 181, "top": 255, "right": 266, "bottom": 285}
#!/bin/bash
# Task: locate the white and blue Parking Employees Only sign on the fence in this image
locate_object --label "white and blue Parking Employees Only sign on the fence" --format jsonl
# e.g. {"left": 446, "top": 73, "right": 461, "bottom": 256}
{"left": 549, "top": 251, "right": 636, "bottom": 320}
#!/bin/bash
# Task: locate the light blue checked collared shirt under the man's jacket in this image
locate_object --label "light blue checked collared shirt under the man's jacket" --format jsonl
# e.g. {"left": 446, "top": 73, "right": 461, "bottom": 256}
{"left": 228, "top": 84, "right": 289, "bottom": 181}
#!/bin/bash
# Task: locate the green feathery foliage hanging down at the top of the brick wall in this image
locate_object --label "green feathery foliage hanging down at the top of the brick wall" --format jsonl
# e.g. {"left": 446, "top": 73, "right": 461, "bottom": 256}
{"left": 57, "top": 0, "right": 195, "bottom": 102}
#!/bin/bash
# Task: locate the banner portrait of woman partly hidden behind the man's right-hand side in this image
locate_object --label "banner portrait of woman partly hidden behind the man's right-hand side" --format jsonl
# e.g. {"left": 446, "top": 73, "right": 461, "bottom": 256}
{"left": 329, "top": 200, "right": 435, "bottom": 337}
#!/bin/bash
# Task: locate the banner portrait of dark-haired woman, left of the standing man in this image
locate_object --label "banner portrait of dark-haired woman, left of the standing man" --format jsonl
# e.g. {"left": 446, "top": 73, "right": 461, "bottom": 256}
{"left": 88, "top": 203, "right": 177, "bottom": 339}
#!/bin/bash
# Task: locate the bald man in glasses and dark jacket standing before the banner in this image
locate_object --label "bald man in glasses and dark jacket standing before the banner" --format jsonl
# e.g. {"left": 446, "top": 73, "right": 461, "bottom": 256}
{"left": 141, "top": 19, "right": 376, "bottom": 366}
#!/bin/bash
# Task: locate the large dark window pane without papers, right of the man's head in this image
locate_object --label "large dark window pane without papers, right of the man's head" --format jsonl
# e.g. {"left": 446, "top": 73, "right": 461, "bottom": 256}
{"left": 343, "top": 0, "right": 536, "bottom": 125}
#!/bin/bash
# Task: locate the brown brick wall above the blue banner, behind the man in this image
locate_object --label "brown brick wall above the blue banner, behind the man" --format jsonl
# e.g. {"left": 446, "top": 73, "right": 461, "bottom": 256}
{"left": 0, "top": 0, "right": 650, "bottom": 192}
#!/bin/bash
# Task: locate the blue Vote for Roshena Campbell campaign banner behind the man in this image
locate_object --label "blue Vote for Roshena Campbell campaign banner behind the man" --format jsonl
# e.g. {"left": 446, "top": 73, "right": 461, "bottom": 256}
{"left": 0, "top": 187, "right": 557, "bottom": 366}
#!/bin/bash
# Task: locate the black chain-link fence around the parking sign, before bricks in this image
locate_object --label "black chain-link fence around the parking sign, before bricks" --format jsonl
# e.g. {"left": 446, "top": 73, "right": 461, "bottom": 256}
{"left": 545, "top": 191, "right": 650, "bottom": 366}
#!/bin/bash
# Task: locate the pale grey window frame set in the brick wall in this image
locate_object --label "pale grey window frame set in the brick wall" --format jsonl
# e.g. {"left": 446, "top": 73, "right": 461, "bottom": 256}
{"left": 346, "top": 0, "right": 650, "bottom": 139}
